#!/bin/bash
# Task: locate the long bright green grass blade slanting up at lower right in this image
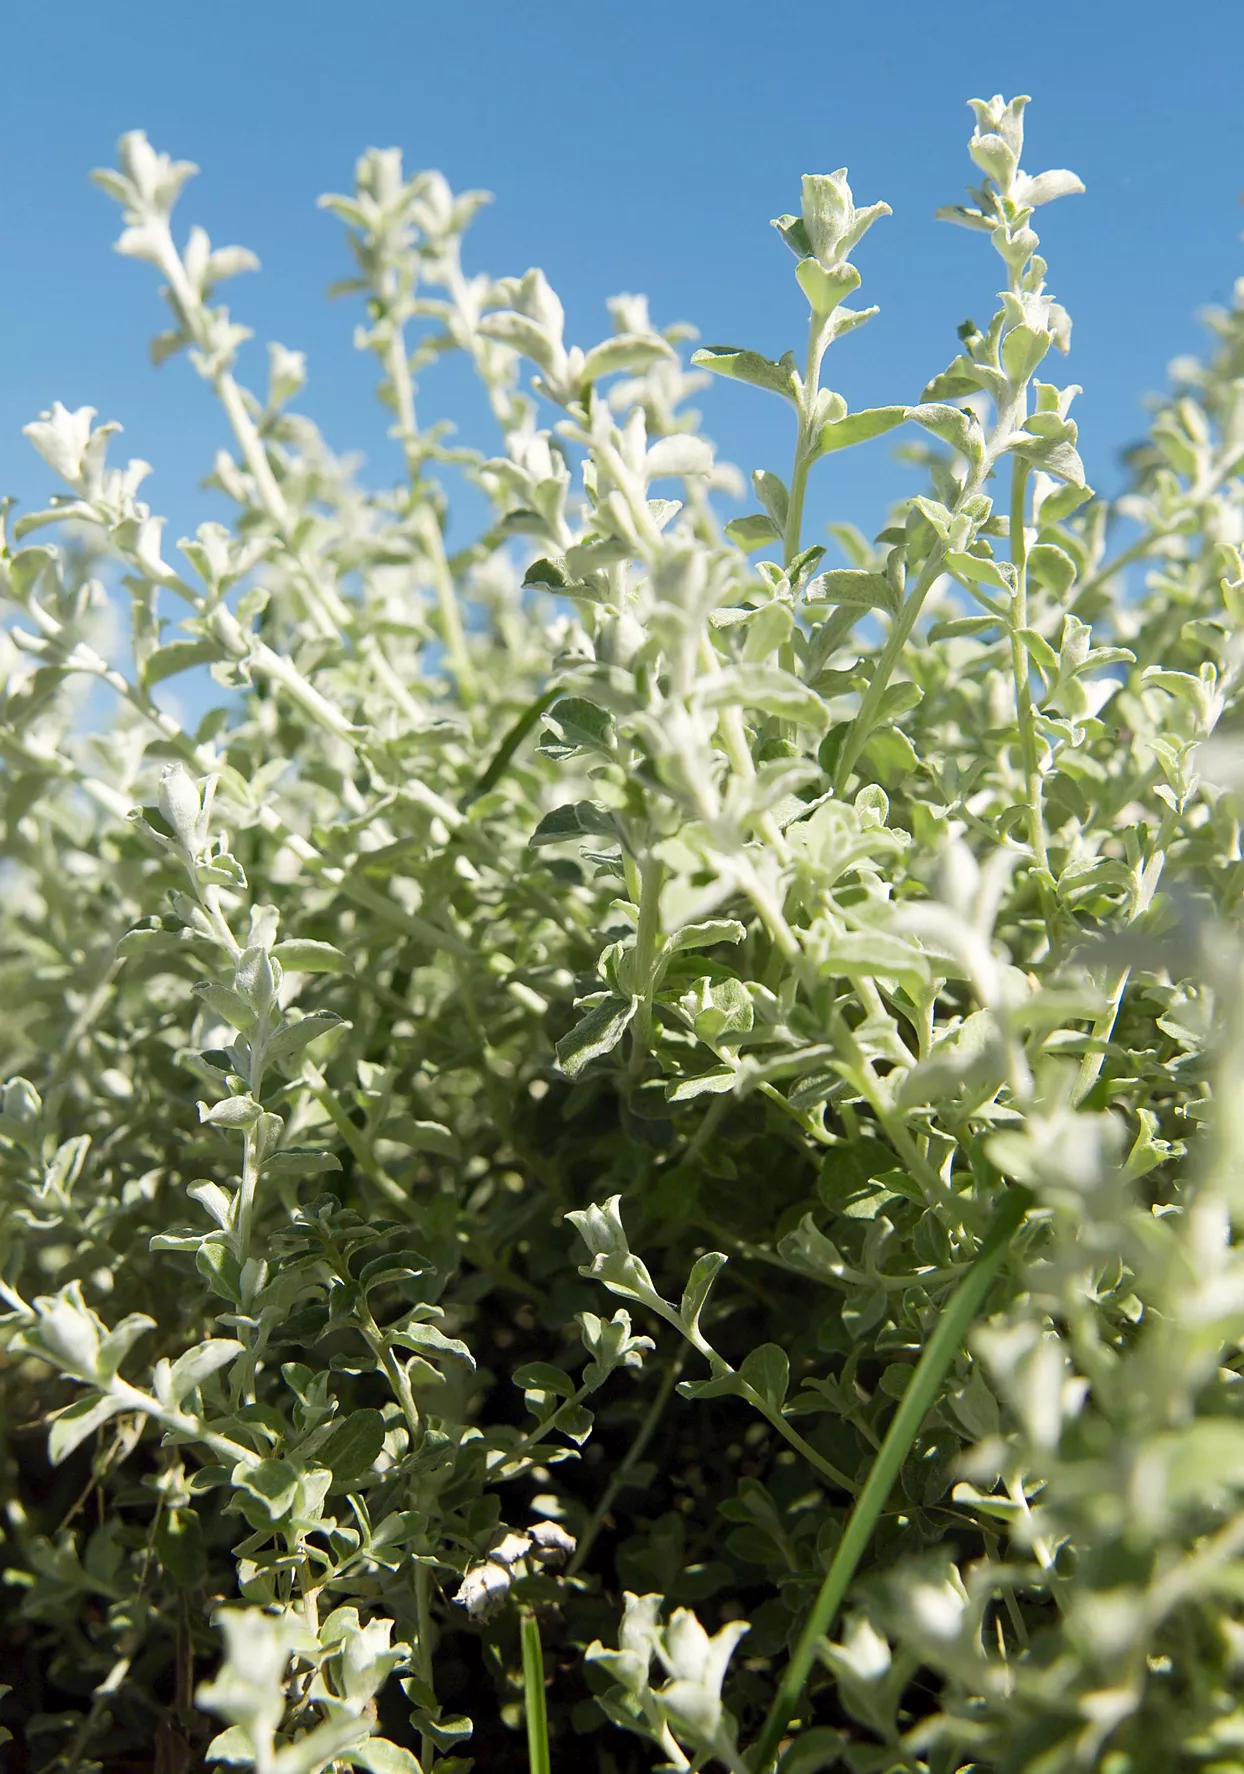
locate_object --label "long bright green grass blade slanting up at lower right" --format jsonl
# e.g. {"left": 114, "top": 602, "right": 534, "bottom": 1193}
{"left": 751, "top": 1185, "right": 1033, "bottom": 1774}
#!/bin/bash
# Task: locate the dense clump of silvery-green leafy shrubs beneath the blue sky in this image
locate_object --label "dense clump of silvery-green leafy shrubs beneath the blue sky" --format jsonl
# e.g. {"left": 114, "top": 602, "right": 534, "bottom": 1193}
{"left": 0, "top": 98, "right": 1244, "bottom": 1774}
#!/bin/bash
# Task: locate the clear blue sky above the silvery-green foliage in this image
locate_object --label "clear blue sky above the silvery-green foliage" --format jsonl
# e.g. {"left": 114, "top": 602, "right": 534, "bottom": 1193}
{"left": 0, "top": 0, "right": 1244, "bottom": 553}
